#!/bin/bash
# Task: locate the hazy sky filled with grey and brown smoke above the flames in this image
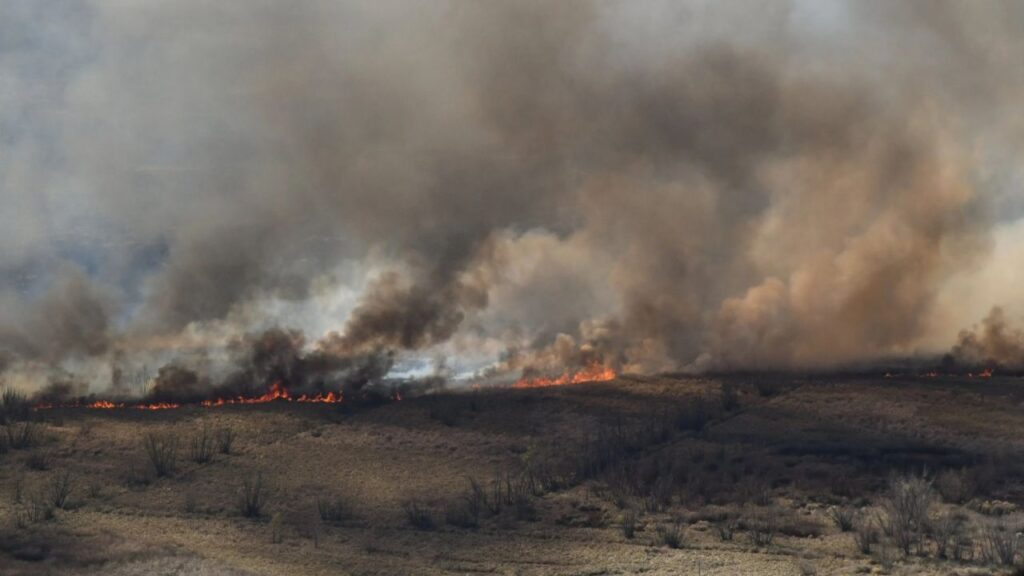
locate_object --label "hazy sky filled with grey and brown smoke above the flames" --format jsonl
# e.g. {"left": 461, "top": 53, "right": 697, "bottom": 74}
{"left": 0, "top": 0, "right": 1024, "bottom": 387}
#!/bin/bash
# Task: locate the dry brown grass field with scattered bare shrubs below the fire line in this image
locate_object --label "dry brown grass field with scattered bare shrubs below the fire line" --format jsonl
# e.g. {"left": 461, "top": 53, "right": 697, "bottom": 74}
{"left": 0, "top": 376, "right": 1024, "bottom": 576}
